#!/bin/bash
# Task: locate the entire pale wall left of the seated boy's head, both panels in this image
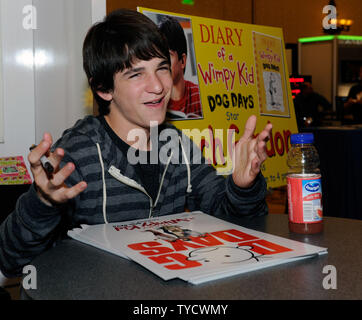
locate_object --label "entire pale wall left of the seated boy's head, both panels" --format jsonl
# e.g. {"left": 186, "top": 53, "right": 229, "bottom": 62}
{"left": 0, "top": 0, "right": 106, "bottom": 165}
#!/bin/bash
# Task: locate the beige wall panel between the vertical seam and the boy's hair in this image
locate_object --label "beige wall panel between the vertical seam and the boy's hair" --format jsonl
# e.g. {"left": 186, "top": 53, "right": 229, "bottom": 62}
{"left": 33, "top": 0, "right": 92, "bottom": 141}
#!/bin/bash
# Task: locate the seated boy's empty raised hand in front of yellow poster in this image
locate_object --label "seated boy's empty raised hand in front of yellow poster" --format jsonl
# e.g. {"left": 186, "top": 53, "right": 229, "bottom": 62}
{"left": 232, "top": 115, "right": 272, "bottom": 188}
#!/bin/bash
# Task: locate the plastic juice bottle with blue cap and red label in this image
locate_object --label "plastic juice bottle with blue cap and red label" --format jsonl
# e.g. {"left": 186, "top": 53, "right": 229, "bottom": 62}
{"left": 287, "top": 133, "right": 323, "bottom": 234}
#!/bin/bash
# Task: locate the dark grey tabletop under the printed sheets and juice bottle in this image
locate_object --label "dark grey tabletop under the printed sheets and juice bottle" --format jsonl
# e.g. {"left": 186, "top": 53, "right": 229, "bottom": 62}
{"left": 22, "top": 214, "right": 362, "bottom": 300}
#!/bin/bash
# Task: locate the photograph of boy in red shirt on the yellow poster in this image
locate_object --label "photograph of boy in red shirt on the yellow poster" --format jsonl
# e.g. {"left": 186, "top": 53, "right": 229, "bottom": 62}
{"left": 142, "top": 11, "right": 203, "bottom": 120}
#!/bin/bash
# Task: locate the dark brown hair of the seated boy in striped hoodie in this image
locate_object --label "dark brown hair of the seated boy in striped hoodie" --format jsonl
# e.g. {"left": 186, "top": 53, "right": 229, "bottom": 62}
{"left": 83, "top": 9, "right": 171, "bottom": 115}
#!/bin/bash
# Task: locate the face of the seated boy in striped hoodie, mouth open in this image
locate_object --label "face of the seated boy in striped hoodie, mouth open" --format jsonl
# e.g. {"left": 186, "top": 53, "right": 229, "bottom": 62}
{"left": 100, "top": 58, "right": 172, "bottom": 130}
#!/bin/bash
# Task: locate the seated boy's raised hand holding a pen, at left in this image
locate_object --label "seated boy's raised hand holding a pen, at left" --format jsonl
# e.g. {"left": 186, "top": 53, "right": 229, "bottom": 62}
{"left": 28, "top": 133, "right": 87, "bottom": 206}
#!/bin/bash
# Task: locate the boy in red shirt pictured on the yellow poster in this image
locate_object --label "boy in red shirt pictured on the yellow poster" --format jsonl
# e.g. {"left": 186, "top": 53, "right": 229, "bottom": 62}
{"left": 159, "top": 16, "right": 203, "bottom": 120}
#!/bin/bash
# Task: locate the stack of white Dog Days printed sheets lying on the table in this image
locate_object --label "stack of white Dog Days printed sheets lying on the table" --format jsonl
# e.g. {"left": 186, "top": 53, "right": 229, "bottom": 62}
{"left": 68, "top": 211, "right": 327, "bottom": 284}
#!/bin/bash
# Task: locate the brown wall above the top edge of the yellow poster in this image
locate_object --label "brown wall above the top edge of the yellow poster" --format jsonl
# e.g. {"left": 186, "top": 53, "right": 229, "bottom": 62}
{"left": 107, "top": 0, "right": 362, "bottom": 43}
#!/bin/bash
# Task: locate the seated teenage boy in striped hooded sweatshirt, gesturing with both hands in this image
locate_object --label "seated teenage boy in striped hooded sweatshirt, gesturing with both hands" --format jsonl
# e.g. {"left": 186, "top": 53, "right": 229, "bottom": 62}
{"left": 0, "top": 10, "right": 271, "bottom": 276}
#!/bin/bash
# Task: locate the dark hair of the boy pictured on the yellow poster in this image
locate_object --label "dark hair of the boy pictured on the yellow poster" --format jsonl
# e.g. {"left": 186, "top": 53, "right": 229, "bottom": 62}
{"left": 159, "top": 16, "right": 187, "bottom": 60}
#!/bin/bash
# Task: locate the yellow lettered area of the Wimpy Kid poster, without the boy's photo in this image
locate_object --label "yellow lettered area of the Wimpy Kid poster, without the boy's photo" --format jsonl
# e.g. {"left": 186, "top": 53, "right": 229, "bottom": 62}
{"left": 138, "top": 7, "right": 298, "bottom": 188}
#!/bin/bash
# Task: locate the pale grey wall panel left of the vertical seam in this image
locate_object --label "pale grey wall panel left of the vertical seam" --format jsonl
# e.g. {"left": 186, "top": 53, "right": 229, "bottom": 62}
{"left": 0, "top": 0, "right": 35, "bottom": 156}
